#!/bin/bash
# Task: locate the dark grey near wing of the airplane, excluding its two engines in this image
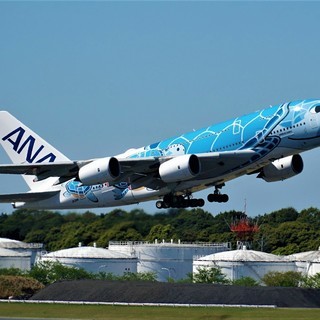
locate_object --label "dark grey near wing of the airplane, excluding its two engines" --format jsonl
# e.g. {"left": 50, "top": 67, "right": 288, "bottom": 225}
{"left": 0, "top": 150, "right": 256, "bottom": 189}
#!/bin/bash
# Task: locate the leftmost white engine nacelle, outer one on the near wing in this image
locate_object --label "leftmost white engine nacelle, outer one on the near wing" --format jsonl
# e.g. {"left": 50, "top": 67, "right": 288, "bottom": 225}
{"left": 78, "top": 157, "right": 120, "bottom": 186}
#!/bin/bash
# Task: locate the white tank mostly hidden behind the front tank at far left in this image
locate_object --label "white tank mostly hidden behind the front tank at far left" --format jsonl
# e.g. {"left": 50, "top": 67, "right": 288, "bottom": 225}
{"left": 0, "top": 238, "right": 43, "bottom": 268}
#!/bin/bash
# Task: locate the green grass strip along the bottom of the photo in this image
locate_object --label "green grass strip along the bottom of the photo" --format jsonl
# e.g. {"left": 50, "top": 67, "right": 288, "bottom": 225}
{"left": 0, "top": 303, "right": 320, "bottom": 320}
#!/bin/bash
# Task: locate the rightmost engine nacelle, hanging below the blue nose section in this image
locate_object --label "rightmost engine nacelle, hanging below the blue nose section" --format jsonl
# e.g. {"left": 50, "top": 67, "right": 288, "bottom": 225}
{"left": 258, "top": 154, "right": 303, "bottom": 182}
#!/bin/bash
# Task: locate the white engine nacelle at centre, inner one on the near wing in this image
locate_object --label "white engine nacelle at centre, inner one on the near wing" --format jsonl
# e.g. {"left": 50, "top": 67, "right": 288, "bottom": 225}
{"left": 159, "top": 154, "right": 201, "bottom": 183}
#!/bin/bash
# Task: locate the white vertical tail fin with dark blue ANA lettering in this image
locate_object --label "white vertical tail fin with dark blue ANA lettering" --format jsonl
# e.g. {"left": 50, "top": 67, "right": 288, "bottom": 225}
{"left": 0, "top": 111, "right": 69, "bottom": 189}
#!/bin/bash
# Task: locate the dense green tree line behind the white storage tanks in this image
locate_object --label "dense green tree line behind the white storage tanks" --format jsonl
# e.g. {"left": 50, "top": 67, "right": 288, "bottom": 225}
{"left": 0, "top": 208, "right": 320, "bottom": 255}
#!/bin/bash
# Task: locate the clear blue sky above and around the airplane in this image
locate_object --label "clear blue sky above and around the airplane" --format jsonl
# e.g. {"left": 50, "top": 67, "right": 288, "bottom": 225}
{"left": 0, "top": 1, "right": 320, "bottom": 215}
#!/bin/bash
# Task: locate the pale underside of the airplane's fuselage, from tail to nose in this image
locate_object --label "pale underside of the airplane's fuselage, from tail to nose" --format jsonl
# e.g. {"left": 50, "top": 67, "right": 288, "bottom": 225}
{"left": 14, "top": 129, "right": 320, "bottom": 209}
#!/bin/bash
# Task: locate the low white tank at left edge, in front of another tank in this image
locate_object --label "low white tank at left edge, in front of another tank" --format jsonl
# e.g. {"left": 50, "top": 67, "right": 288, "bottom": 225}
{"left": 0, "top": 248, "right": 31, "bottom": 270}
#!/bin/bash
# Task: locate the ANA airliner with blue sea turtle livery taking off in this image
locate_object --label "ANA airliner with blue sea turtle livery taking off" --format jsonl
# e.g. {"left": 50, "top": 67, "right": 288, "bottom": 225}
{"left": 0, "top": 99, "right": 320, "bottom": 209}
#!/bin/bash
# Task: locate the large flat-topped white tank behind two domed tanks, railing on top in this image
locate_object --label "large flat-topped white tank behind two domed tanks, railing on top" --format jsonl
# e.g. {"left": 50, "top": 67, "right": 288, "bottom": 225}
{"left": 109, "top": 241, "right": 230, "bottom": 281}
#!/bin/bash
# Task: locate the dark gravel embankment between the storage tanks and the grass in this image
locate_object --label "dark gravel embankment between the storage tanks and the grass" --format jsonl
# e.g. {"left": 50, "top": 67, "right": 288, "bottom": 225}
{"left": 31, "top": 280, "right": 320, "bottom": 308}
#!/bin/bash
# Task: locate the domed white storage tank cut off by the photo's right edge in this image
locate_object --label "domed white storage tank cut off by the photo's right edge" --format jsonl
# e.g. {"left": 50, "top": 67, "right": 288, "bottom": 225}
{"left": 287, "top": 248, "right": 320, "bottom": 276}
